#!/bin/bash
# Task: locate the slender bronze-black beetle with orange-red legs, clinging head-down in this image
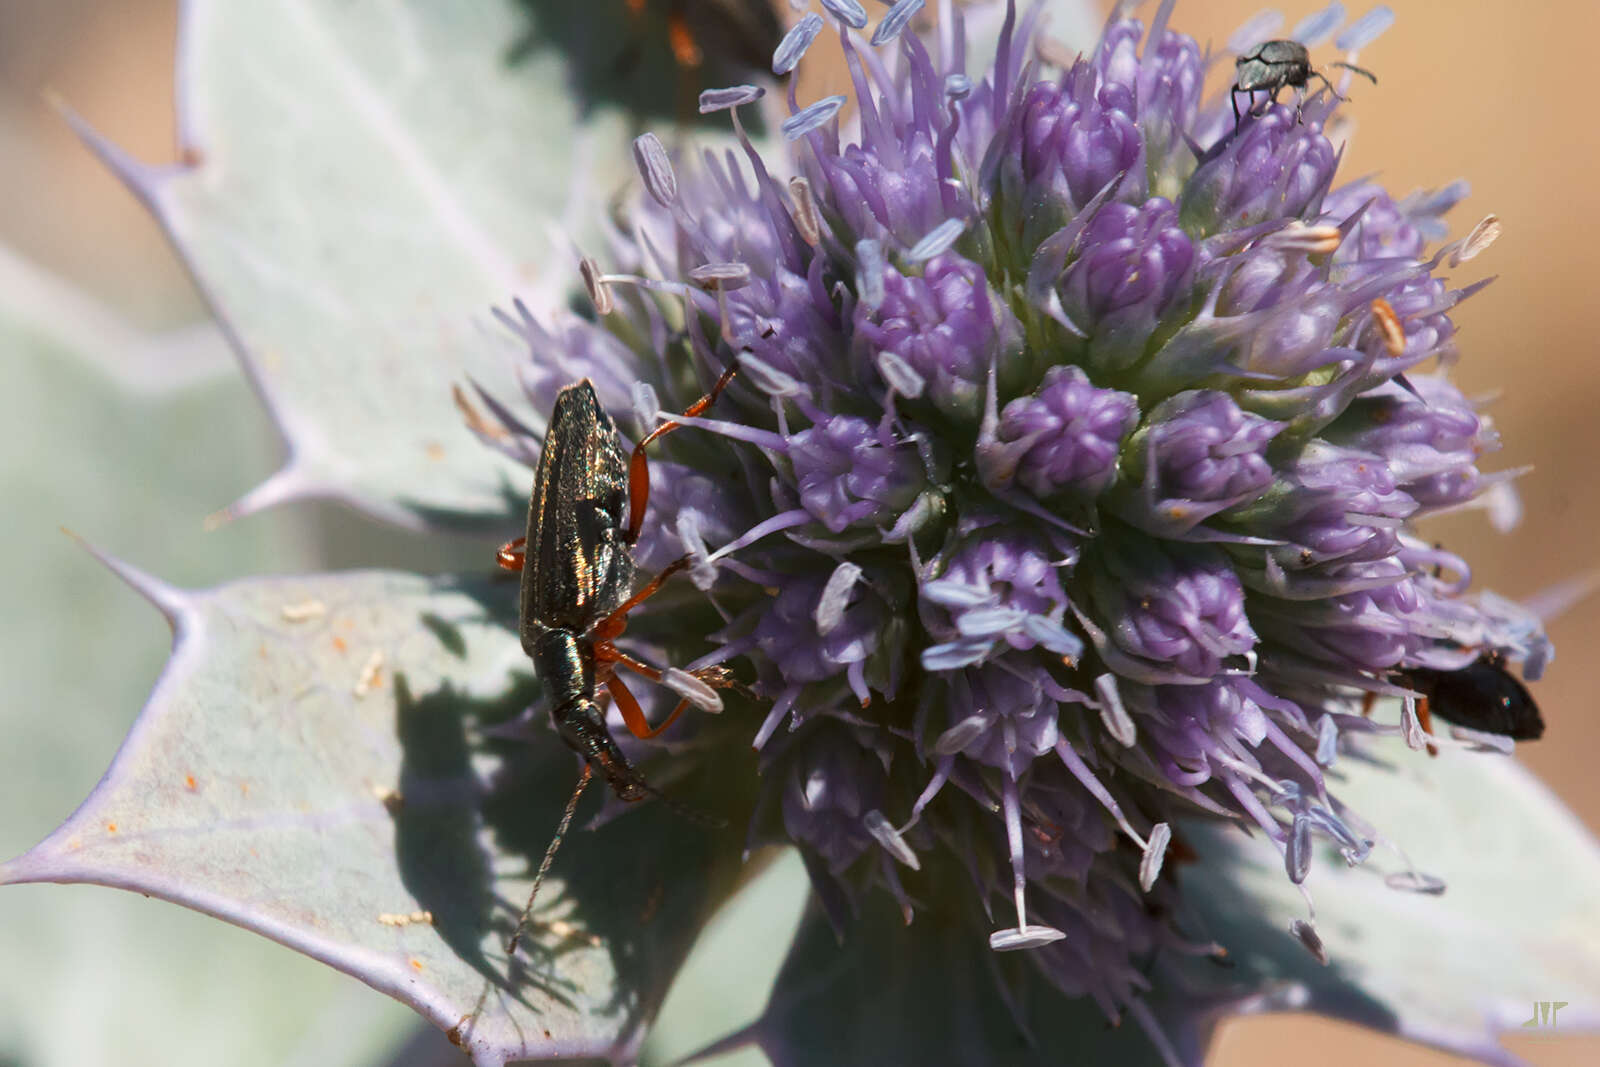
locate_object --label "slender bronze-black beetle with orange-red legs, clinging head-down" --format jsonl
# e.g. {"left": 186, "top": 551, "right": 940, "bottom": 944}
{"left": 498, "top": 366, "right": 734, "bottom": 955}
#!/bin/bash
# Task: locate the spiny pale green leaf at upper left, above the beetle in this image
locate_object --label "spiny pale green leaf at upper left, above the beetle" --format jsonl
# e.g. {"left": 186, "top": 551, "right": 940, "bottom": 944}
{"left": 67, "top": 0, "right": 668, "bottom": 526}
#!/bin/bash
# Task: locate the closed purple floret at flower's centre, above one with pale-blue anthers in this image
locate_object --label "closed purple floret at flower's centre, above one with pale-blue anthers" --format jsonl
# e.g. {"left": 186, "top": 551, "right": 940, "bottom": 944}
{"left": 986, "top": 366, "right": 1139, "bottom": 498}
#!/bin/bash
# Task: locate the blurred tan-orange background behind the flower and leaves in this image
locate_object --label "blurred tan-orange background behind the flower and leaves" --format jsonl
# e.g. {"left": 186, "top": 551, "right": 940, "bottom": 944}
{"left": 0, "top": 0, "right": 1600, "bottom": 1067}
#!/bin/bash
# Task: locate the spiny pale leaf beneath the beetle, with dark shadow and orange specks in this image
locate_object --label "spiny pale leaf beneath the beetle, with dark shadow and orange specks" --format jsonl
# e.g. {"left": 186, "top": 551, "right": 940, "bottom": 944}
{"left": 0, "top": 565, "right": 739, "bottom": 1064}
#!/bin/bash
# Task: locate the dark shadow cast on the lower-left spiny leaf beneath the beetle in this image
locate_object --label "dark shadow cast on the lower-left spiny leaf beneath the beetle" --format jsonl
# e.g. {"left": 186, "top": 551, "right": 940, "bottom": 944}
{"left": 389, "top": 643, "right": 754, "bottom": 1013}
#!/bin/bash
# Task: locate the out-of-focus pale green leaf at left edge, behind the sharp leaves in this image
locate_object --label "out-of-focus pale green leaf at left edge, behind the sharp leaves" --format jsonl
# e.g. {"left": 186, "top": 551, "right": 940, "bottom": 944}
{"left": 0, "top": 259, "right": 414, "bottom": 1067}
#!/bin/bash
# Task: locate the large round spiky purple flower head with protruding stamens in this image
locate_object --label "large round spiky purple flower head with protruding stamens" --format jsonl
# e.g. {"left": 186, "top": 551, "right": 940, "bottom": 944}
{"left": 473, "top": 3, "right": 1549, "bottom": 1049}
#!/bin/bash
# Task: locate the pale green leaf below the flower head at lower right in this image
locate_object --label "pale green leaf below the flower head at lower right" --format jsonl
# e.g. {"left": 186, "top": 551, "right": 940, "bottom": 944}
{"left": 1182, "top": 752, "right": 1600, "bottom": 1064}
